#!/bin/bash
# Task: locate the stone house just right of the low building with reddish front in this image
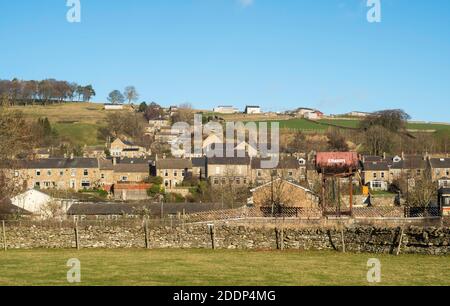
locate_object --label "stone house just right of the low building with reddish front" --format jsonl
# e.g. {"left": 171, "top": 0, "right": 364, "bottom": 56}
{"left": 150, "top": 159, "right": 192, "bottom": 189}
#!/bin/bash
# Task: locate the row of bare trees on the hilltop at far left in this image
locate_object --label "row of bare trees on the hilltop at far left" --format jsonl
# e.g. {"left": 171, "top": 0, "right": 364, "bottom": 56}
{"left": 0, "top": 79, "right": 96, "bottom": 106}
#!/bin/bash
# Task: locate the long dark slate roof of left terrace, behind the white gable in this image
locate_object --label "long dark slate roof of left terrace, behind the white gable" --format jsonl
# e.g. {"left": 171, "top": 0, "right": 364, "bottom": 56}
{"left": 20, "top": 158, "right": 99, "bottom": 169}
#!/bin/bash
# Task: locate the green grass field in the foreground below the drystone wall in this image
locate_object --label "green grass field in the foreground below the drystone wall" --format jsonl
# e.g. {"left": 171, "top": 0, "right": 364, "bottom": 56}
{"left": 0, "top": 250, "right": 450, "bottom": 286}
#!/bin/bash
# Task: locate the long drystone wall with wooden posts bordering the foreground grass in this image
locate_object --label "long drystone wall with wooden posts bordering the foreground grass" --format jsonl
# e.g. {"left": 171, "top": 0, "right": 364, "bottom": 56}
{"left": 0, "top": 223, "right": 450, "bottom": 255}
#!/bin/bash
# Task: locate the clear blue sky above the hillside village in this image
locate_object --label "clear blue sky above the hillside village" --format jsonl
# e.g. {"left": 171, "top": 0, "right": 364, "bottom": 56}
{"left": 0, "top": 0, "right": 450, "bottom": 121}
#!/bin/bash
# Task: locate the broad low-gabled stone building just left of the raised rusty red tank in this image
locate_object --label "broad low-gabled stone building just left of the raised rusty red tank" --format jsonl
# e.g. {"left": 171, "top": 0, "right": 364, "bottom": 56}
{"left": 250, "top": 179, "right": 319, "bottom": 208}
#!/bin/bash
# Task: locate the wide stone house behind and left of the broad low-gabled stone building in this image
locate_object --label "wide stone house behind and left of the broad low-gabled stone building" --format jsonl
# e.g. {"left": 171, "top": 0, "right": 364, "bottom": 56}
{"left": 206, "top": 157, "right": 251, "bottom": 188}
